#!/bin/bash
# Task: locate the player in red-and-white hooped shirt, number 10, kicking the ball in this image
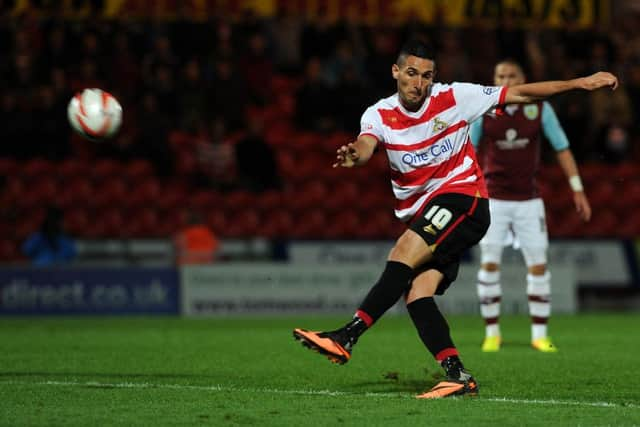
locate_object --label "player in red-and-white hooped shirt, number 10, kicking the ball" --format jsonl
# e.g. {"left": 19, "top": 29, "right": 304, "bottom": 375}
{"left": 293, "top": 40, "right": 618, "bottom": 399}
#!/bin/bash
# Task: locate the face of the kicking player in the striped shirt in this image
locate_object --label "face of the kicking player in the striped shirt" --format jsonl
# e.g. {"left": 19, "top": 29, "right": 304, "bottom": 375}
{"left": 392, "top": 55, "right": 435, "bottom": 111}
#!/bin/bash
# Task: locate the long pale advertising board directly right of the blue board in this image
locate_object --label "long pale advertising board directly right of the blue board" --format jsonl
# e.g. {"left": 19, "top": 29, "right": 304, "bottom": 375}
{"left": 180, "top": 263, "right": 577, "bottom": 316}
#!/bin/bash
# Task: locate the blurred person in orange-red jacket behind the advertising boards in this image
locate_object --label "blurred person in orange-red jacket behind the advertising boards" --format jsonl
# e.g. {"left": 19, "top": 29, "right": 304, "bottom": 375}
{"left": 174, "top": 211, "right": 220, "bottom": 265}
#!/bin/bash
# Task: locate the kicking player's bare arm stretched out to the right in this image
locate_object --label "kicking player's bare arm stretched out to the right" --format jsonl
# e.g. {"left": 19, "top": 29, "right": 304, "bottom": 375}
{"left": 505, "top": 71, "right": 618, "bottom": 104}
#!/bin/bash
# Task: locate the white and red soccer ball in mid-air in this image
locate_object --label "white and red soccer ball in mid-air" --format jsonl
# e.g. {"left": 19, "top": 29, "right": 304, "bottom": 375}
{"left": 67, "top": 89, "right": 122, "bottom": 141}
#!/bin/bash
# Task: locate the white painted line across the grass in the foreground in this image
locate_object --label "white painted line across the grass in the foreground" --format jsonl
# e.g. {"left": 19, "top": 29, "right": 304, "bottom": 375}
{"left": 0, "top": 381, "right": 640, "bottom": 409}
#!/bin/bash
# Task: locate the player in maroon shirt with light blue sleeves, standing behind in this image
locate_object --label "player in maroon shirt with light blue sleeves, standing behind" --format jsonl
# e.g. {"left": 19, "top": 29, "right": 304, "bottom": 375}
{"left": 471, "top": 60, "right": 591, "bottom": 353}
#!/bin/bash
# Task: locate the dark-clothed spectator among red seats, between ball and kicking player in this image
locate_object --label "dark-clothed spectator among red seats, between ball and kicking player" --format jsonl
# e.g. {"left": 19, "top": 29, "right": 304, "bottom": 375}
{"left": 235, "top": 117, "right": 281, "bottom": 192}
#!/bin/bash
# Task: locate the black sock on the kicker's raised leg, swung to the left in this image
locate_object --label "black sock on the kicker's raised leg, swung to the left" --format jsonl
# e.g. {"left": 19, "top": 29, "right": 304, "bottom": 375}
{"left": 358, "top": 261, "right": 414, "bottom": 326}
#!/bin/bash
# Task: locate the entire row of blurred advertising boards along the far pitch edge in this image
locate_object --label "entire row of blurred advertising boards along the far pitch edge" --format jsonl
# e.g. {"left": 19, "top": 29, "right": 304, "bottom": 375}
{"left": 0, "top": 240, "right": 640, "bottom": 316}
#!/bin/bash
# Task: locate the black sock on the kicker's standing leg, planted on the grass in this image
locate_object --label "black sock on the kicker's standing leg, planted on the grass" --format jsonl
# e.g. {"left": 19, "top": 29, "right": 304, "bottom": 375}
{"left": 407, "top": 297, "right": 458, "bottom": 362}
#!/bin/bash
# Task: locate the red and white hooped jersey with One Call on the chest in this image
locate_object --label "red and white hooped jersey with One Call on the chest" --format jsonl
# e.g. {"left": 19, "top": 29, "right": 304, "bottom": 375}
{"left": 360, "top": 83, "right": 506, "bottom": 221}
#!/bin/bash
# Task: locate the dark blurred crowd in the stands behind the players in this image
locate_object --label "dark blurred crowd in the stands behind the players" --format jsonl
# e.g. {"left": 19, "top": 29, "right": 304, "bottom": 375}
{"left": 0, "top": 5, "right": 640, "bottom": 260}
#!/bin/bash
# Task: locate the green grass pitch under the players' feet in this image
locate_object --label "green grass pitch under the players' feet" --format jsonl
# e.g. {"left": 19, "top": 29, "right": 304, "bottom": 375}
{"left": 0, "top": 314, "right": 640, "bottom": 427}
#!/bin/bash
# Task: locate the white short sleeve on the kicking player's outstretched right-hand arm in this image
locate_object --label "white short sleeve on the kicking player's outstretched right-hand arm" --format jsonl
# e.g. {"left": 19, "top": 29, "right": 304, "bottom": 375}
{"left": 451, "top": 83, "right": 507, "bottom": 123}
